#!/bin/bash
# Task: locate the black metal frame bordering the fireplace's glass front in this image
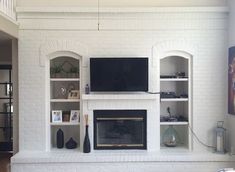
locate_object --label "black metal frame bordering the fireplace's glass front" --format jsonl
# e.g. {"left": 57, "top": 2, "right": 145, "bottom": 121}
{"left": 93, "top": 110, "right": 147, "bottom": 150}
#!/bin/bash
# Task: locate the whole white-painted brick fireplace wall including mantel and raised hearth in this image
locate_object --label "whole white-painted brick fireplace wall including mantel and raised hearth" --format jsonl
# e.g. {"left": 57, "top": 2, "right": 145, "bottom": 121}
{"left": 11, "top": 7, "right": 235, "bottom": 172}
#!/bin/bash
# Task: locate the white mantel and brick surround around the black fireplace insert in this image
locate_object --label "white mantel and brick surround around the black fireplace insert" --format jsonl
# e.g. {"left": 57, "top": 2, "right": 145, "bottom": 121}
{"left": 81, "top": 93, "right": 160, "bottom": 152}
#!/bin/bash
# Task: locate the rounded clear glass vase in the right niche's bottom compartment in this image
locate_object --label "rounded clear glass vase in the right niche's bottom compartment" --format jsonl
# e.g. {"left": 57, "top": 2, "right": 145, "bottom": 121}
{"left": 162, "top": 125, "right": 180, "bottom": 147}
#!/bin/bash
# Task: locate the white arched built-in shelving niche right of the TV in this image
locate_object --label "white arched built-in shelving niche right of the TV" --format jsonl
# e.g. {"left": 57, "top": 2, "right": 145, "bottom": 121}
{"left": 158, "top": 55, "right": 192, "bottom": 152}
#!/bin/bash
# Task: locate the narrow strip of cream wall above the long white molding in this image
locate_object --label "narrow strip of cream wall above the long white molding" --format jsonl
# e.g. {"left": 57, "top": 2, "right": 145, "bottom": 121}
{"left": 17, "top": 0, "right": 227, "bottom": 7}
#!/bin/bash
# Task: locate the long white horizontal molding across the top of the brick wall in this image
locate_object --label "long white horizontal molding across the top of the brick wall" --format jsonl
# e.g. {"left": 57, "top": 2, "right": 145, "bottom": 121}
{"left": 16, "top": 7, "right": 229, "bottom": 13}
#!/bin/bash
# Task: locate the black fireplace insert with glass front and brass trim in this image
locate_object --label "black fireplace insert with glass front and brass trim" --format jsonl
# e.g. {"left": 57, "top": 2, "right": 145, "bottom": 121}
{"left": 94, "top": 110, "right": 147, "bottom": 149}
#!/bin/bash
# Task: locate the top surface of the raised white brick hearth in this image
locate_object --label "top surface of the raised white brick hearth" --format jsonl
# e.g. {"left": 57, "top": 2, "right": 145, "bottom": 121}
{"left": 11, "top": 150, "right": 235, "bottom": 164}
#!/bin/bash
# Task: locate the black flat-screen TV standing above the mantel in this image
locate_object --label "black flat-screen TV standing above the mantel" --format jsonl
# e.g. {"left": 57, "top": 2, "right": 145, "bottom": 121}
{"left": 90, "top": 58, "right": 148, "bottom": 92}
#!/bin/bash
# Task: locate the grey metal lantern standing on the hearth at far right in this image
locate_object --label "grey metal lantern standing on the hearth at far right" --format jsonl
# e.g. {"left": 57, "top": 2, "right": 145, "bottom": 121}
{"left": 215, "top": 121, "right": 226, "bottom": 154}
